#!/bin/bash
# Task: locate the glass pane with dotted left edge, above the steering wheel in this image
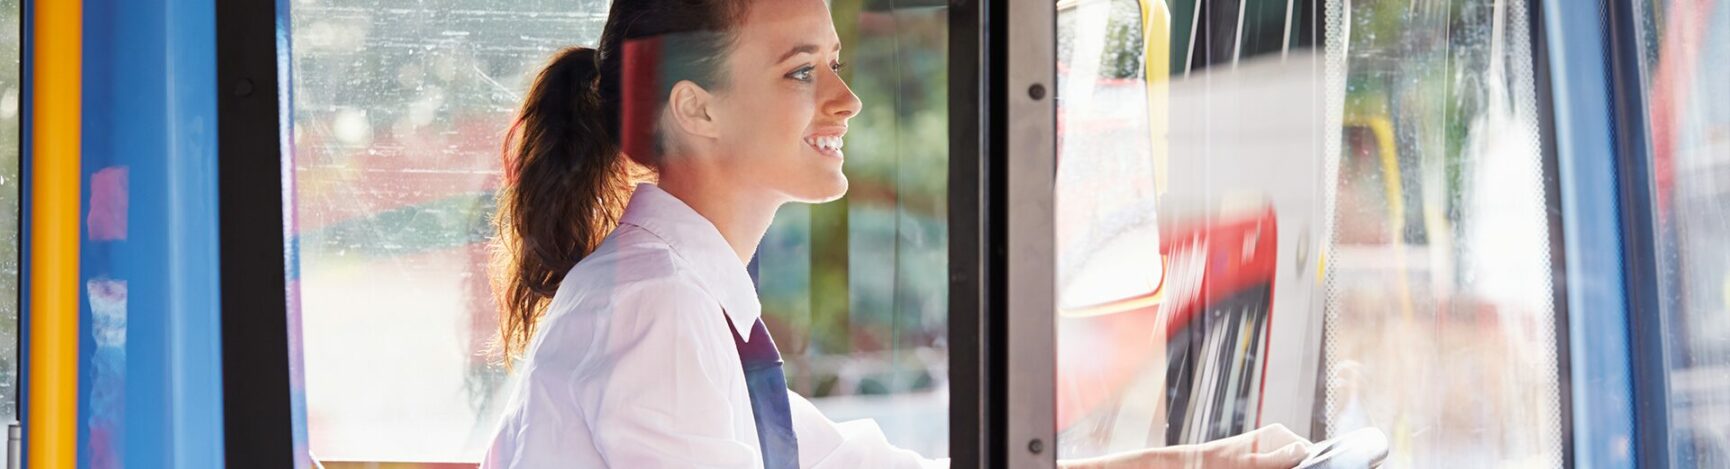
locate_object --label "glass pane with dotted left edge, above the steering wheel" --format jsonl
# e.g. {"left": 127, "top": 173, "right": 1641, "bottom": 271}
{"left": 1322, "top": 0, "right": 1566, "bottom": 467}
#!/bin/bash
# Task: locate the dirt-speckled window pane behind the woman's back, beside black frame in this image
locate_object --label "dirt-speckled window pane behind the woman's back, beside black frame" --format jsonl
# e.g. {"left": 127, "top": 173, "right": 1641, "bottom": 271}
{"left": 291, "top": 0, "right": 607, "bottom": 462}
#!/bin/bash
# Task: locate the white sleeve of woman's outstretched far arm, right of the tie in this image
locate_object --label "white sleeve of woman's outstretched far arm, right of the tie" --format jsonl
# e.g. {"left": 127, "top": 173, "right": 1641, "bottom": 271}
{"left": 787, "top": 391, "right": 950, "bottom": 469}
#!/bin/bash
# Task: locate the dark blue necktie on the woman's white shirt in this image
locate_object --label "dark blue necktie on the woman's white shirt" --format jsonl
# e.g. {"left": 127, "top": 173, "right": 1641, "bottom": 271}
{"left": 727, "top": 318, "right": 799, "bottom": 469}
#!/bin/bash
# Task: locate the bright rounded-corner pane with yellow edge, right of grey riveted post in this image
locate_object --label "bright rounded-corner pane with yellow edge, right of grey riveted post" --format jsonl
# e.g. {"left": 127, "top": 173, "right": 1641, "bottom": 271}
{"left": 1057, "top": 0, "right": 1164, "bottom": 315}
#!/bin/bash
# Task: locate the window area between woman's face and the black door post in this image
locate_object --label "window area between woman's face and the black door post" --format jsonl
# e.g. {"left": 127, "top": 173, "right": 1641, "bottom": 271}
{"left": 756, "top": 2, "right": 950, "bottom": 457}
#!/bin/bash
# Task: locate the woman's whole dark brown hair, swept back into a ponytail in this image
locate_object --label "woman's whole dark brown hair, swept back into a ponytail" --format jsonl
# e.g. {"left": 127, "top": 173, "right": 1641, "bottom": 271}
{"left": 491, "top": 0, "right": 744, "bottom": 363}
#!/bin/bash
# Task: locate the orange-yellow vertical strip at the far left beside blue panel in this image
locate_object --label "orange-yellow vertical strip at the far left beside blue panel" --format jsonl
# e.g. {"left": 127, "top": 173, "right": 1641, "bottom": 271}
{"left": 24, "top": 0, "right": 83, "bottom": 469}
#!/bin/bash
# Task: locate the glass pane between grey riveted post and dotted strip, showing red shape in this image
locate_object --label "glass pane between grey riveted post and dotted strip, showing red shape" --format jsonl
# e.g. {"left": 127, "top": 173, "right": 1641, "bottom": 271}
{"left": 1055, "top": 0, "right": 1323, "bottom": 457}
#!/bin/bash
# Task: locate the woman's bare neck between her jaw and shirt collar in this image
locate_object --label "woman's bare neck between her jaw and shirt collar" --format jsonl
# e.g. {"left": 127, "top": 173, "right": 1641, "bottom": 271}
{"left": 656, "top": 173, "right": 780, "bottom": 263}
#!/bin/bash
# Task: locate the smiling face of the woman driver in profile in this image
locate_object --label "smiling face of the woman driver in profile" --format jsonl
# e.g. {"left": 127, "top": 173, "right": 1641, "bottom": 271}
{"left": 711, "top": 0, "right": 860, "bottom": 202}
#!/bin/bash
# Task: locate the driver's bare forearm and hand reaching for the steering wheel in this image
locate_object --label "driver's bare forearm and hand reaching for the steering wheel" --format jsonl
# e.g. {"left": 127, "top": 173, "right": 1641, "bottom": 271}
{"left": 1057, "top": 424, "right": 1310, "bottom": 469}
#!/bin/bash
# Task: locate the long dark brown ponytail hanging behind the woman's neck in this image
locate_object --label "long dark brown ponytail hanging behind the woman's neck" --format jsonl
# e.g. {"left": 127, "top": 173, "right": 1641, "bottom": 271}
{"left": 493, "top": 47, "right": 631, "bottom": 363}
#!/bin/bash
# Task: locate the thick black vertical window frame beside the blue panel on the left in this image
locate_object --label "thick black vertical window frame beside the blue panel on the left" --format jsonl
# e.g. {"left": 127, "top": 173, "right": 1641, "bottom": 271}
{"left": 215, "top": 0, "right": 296, "bottom": 467}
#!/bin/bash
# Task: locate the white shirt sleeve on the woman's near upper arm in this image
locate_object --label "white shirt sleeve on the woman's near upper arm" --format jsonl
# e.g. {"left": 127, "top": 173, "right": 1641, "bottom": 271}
{"left": 573, "top": 282, "right": 763, "bottom": 469}
